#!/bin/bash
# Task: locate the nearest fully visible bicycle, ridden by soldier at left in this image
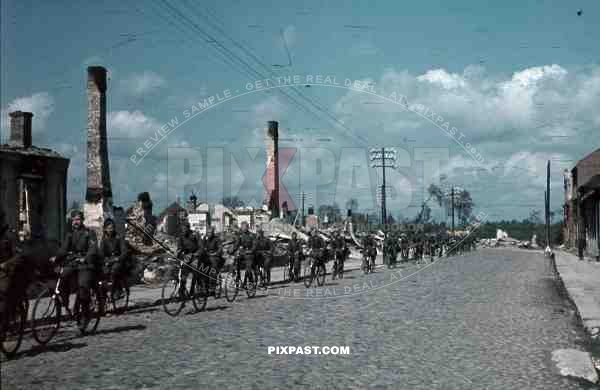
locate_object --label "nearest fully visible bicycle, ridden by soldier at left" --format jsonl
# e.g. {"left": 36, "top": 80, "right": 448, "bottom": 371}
{"left": 32, "top": 258, "right": 104, "bottom": 345}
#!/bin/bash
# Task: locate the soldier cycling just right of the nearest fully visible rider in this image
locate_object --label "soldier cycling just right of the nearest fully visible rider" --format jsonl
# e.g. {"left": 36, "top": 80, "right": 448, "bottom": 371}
{"left": 100, "top": 219, "right": 131, "bottom": 294}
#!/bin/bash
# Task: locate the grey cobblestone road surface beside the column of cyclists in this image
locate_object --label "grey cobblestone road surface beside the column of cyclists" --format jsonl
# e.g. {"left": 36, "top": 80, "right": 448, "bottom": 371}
{"left": 2, "top": 249, "right": 588, "bottom": 390}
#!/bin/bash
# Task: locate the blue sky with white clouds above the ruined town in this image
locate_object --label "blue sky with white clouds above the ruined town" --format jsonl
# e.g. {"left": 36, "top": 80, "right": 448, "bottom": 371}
{"left": 0, "top": 0, "right": 600, "bottom": 220}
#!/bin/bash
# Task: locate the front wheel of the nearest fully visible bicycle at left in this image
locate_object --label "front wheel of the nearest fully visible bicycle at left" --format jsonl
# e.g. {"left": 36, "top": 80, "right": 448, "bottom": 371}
{"left": 31, "top": 288, "right": 61, "bottom": 345}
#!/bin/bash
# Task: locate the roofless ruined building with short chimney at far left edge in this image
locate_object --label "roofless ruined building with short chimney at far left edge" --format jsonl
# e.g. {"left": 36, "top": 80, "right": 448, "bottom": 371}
{"left": 0, "top": 111, "right": 69, "bottom": 243}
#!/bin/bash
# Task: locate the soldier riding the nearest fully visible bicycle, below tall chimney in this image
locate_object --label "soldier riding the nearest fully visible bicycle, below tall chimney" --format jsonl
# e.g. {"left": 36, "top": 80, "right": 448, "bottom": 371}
{"left": 50, "top": 210, "right": 102, "bottom": 326}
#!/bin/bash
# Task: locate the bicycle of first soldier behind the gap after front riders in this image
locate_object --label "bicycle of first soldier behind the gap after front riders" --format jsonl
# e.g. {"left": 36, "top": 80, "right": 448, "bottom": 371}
{"left": 161, "top": 259, "right": 208, "bottom": 317}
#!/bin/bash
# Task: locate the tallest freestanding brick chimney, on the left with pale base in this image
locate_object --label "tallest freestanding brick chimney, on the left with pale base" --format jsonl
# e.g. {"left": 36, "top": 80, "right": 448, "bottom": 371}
{"left": 84, "top": 66, "right": 112, "bottom": 239}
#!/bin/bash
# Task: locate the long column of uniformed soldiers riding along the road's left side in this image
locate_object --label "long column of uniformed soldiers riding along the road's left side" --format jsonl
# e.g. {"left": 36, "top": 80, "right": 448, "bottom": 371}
{"left": 0, "top": 209, "right": 474, "bottom": 330}
